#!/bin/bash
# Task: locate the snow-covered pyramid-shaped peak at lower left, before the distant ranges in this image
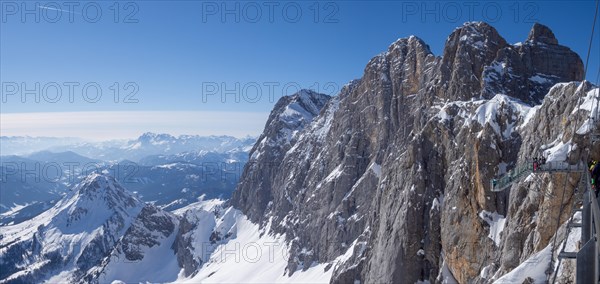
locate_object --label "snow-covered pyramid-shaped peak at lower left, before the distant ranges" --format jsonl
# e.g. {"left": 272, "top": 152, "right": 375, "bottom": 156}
{"left": 0, "top": 174, "right": 146, "bottom": 283}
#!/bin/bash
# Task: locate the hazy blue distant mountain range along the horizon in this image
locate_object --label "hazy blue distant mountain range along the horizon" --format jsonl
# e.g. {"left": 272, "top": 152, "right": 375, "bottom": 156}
{"left": 0, "top": 133, "right": 255, "bottom": 226}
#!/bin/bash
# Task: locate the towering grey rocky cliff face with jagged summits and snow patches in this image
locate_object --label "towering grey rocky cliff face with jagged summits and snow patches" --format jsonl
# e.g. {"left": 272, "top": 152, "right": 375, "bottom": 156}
{"left": 232, "top": 23, "right": 598, "bottom": 283}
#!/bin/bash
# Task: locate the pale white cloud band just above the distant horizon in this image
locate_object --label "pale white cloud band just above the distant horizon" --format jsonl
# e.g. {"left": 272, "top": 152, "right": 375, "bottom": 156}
{"left": 0, "top": 111, "right": 269, "bottom": 140}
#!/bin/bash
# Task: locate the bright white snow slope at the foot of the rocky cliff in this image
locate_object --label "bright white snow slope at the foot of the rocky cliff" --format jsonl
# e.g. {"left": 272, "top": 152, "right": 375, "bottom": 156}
{"left": 177, "top": 212, "right": 333, "bottom": 283}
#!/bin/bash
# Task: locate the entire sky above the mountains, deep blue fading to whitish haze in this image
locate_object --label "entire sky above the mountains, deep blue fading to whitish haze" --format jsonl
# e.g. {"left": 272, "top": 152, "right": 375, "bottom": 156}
{"left": 0, "top": 0, "right": 600, "bottom": 139}
